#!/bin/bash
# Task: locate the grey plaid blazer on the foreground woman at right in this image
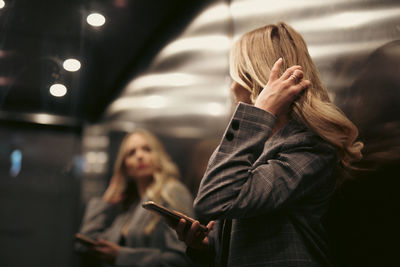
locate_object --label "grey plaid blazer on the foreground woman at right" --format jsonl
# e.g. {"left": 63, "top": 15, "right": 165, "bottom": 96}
{"left": 194, "top": 103, "right": 338, "bottom": 267}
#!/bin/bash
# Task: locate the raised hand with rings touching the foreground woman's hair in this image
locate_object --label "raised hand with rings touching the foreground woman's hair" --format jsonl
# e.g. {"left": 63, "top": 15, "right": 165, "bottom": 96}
{"left": 254, "top": 58, "right": 311, "bottom": 117}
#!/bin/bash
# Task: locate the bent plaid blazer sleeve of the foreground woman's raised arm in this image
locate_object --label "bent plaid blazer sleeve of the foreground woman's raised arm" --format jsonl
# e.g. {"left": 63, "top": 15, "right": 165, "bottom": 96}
{"left": 194, "top": 103, "right": 336, "bottom": 220}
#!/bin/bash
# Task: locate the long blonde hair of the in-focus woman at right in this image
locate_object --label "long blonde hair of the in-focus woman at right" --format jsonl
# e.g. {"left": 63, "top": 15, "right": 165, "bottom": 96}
{"left": 230, "top": 22, "right": 363, "bottom": 178}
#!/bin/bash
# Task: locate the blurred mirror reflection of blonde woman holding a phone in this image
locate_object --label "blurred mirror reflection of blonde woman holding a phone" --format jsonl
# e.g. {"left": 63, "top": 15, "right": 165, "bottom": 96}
{"left": 78, "top": 130, "right": 193, "bottom": 266}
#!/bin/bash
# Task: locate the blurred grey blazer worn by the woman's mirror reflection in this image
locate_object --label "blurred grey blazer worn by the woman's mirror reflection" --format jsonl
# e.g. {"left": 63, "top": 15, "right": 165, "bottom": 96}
{"left": 76, "top": 181, "right": 193, "bottom": 267}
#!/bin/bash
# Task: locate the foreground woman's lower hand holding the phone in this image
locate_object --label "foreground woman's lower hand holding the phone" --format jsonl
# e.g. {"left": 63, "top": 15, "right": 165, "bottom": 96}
{"left": 167, "top": 219, "right": 214, "bottom": 250}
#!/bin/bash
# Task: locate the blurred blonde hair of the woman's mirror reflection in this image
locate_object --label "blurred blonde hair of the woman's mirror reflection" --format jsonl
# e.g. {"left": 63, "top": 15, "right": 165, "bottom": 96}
{"left": 114, "top": 129, "right": 182, "bottom": 234}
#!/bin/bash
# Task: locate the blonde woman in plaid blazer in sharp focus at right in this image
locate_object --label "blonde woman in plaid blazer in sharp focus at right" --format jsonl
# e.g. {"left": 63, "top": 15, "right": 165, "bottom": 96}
{"left": 170, "top": 23, "right": 363, "bottom": 267}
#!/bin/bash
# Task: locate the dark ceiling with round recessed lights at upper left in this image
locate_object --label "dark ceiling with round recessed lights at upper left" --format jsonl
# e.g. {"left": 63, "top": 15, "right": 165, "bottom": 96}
{"left": 0, "top": 0, "right": 212, "bottom": 126}
